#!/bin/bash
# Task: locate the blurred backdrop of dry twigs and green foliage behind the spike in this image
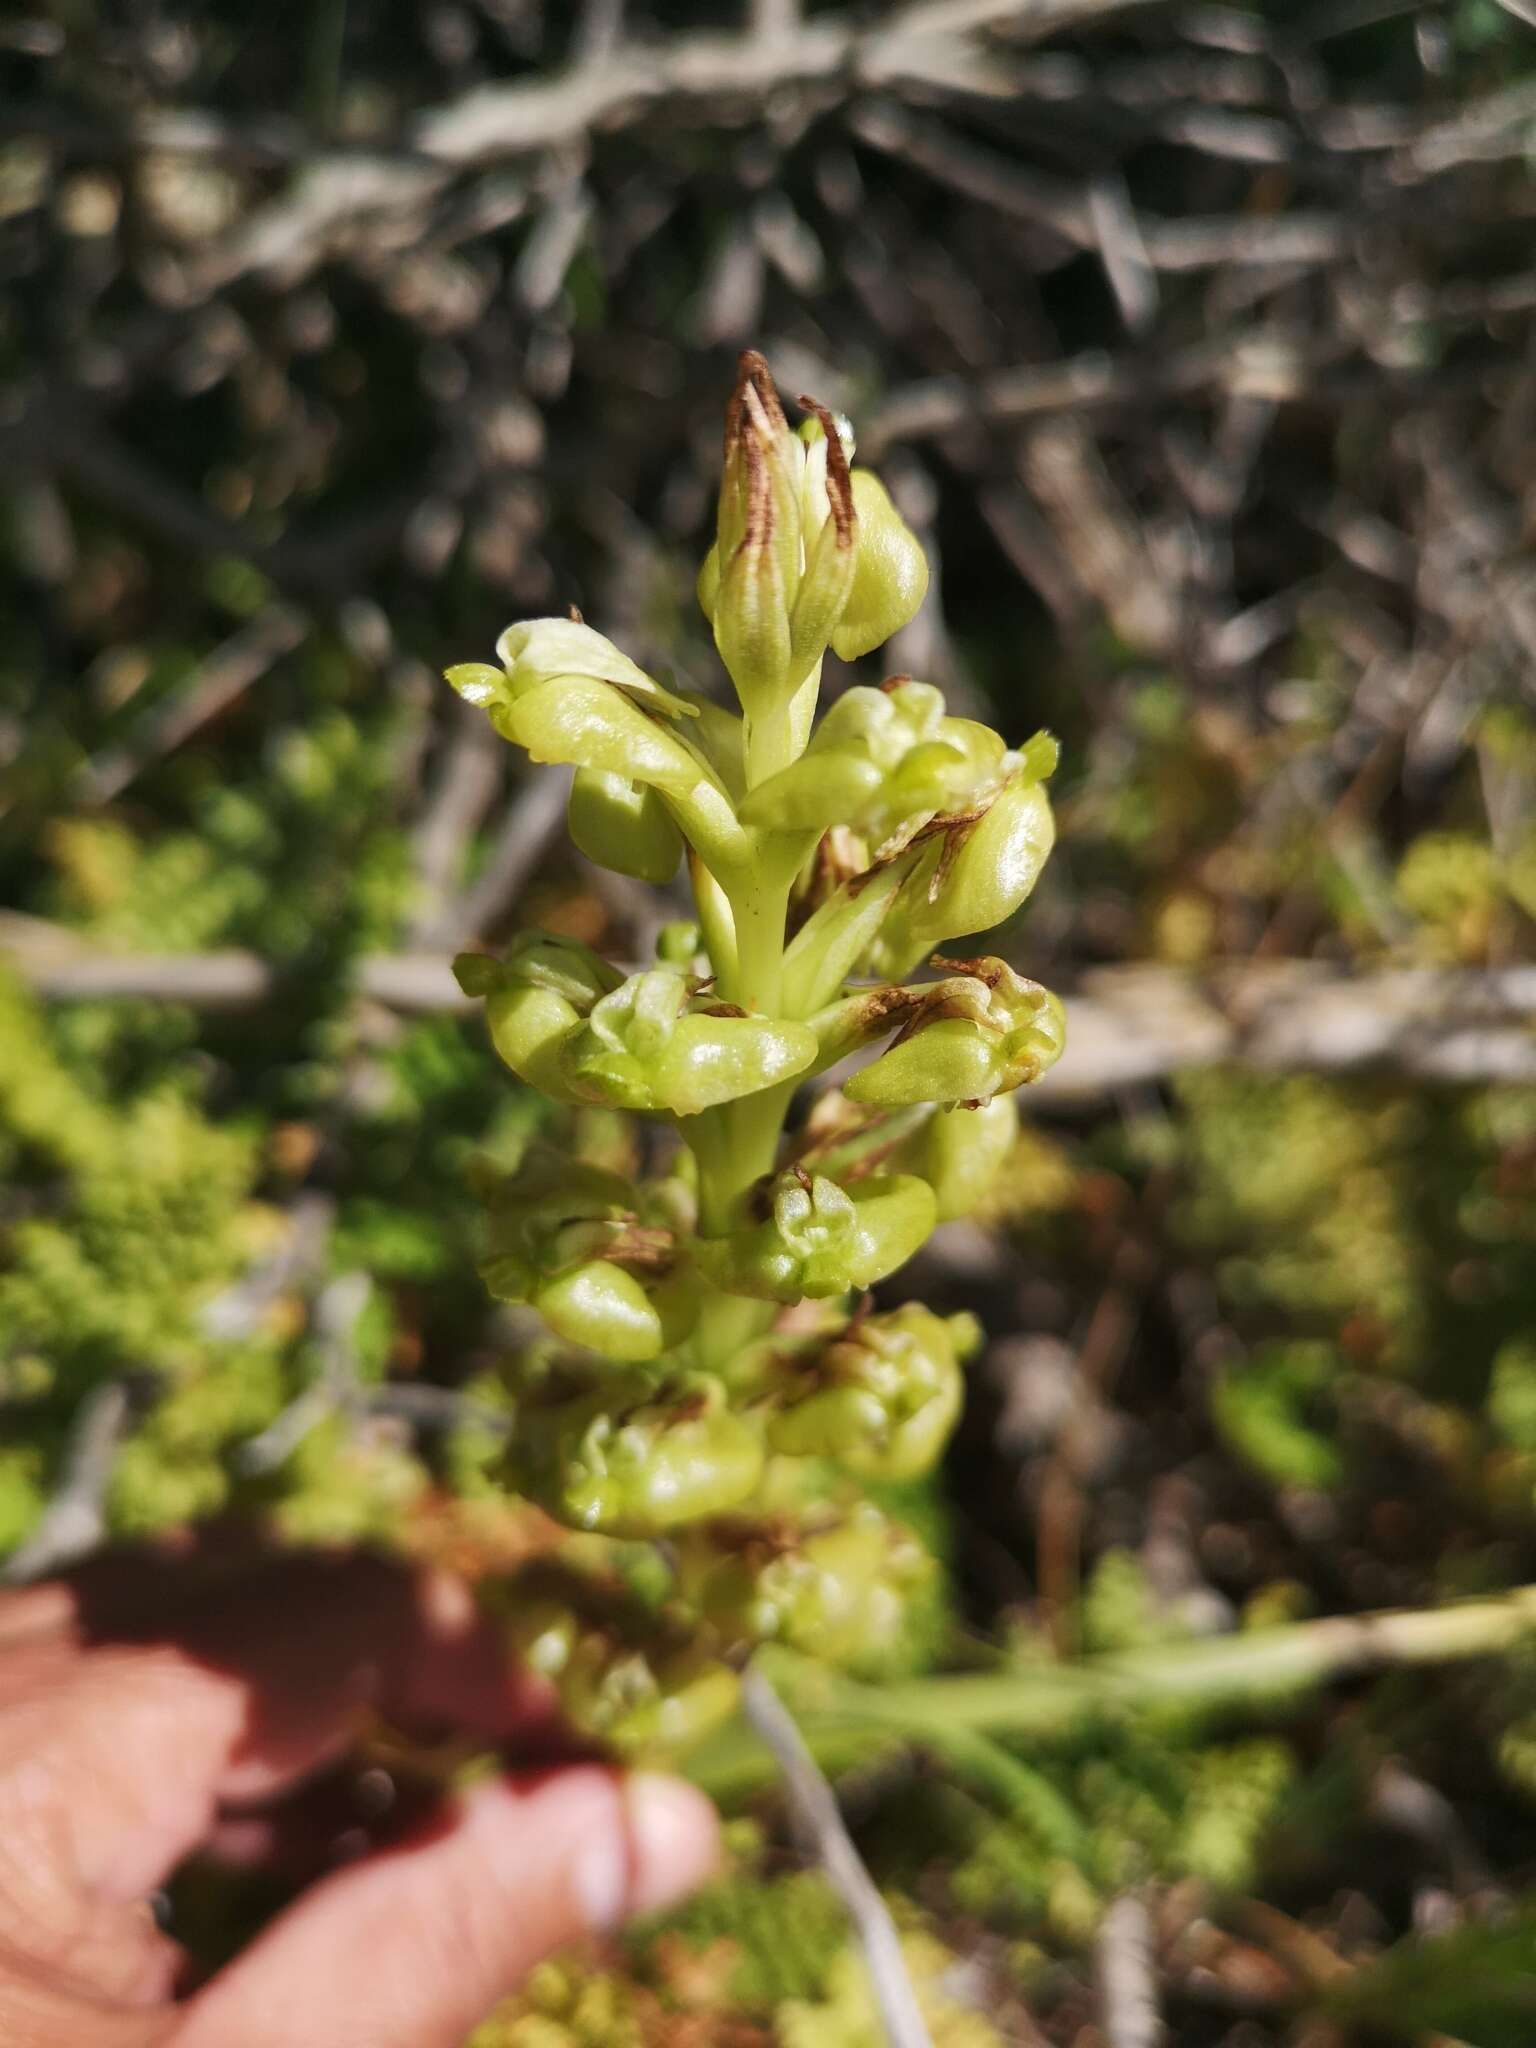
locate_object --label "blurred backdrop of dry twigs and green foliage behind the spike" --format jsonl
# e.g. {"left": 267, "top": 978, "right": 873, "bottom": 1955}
{"left": 0, "top": 0, "right": 1536, "bottom": 2048}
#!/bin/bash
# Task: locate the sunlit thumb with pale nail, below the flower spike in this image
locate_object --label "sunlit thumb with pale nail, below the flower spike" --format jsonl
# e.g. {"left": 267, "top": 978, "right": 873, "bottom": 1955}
{"left": 174, "top": 1765, "right": 719, "bottom": 2048}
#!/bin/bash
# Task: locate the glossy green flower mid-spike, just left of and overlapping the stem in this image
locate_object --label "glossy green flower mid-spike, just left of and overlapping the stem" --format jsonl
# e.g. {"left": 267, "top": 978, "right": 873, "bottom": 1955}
{"left": 565, "top": 967, "right": 815, "bottom": 1116}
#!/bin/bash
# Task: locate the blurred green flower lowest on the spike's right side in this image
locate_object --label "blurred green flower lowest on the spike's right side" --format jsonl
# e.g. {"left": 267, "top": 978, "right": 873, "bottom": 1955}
{"left": 690, "top": 1505, "right": 938, "bottom": 1675}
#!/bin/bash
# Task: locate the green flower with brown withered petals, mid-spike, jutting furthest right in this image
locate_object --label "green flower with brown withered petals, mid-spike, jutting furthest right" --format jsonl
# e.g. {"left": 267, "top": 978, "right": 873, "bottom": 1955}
{"left": 840, "top": 956, "right": 1065, "bottom": 1108}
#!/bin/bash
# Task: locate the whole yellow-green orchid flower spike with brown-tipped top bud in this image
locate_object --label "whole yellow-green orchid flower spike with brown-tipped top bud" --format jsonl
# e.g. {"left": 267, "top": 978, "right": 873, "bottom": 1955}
{"left": 449, "top": 352, "right": 1065, "bottom": 1755}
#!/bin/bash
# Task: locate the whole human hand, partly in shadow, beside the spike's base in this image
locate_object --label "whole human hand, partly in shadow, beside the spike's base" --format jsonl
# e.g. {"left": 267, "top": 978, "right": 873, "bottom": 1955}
{"left": 0, "top": 1556, "right": 717, "bottom": 2048}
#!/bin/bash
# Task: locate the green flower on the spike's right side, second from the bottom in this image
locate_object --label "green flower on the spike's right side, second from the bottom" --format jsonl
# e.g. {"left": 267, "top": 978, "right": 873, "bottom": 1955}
{"left": 768, "top": 1303, "right": 975, "bottom": 1481}
